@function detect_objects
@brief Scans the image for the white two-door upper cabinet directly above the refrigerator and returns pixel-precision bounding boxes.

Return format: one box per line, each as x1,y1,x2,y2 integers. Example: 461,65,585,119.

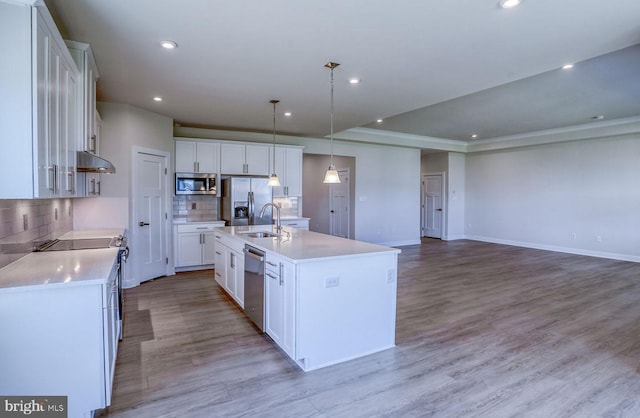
220,143,271,176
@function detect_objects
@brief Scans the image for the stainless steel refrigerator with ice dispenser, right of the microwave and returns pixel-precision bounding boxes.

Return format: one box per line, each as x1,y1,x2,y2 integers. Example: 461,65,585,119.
222,177,273,226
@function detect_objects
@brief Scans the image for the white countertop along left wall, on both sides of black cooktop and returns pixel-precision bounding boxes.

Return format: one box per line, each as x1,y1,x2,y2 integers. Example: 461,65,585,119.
0,228,125,293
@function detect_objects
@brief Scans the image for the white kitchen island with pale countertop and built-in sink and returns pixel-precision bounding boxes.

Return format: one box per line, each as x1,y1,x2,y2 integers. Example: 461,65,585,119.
216,225,400,371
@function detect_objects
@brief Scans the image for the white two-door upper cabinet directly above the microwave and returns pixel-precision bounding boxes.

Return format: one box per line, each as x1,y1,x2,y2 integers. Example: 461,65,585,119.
176,140,220,173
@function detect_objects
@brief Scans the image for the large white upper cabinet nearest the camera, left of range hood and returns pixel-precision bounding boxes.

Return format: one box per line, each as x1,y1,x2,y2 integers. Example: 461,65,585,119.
0,1,80,199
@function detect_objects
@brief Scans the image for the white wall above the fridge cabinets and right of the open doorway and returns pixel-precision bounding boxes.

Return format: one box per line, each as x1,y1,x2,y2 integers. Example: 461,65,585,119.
175,128,420,246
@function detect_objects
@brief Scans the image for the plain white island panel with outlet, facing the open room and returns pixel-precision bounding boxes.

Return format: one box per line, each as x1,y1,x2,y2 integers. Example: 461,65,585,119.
294,253,397,371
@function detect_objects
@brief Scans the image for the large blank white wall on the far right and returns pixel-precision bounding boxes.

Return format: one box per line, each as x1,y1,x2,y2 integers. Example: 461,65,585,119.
465,135,640,261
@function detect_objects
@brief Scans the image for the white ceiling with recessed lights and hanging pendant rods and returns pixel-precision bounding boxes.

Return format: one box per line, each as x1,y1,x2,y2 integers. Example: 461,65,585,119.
47,0,640,146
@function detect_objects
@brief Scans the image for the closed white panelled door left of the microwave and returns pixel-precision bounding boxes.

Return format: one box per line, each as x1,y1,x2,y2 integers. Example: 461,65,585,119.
132,152,167,282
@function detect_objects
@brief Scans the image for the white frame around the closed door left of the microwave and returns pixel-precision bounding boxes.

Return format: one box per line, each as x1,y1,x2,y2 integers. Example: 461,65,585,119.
126,145,173,287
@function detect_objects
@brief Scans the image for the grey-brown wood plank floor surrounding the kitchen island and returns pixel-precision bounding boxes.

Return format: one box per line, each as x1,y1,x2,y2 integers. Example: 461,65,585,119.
103,240,640,418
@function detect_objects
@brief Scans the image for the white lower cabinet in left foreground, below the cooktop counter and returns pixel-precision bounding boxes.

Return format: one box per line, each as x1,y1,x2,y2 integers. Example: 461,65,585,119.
0,256,121,417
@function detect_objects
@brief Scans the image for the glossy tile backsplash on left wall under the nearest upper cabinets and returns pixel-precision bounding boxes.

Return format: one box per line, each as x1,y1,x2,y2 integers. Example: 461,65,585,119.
0,199,73,268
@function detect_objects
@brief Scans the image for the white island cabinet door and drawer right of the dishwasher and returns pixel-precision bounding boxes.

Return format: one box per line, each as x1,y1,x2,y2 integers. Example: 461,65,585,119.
264,252,295,358
